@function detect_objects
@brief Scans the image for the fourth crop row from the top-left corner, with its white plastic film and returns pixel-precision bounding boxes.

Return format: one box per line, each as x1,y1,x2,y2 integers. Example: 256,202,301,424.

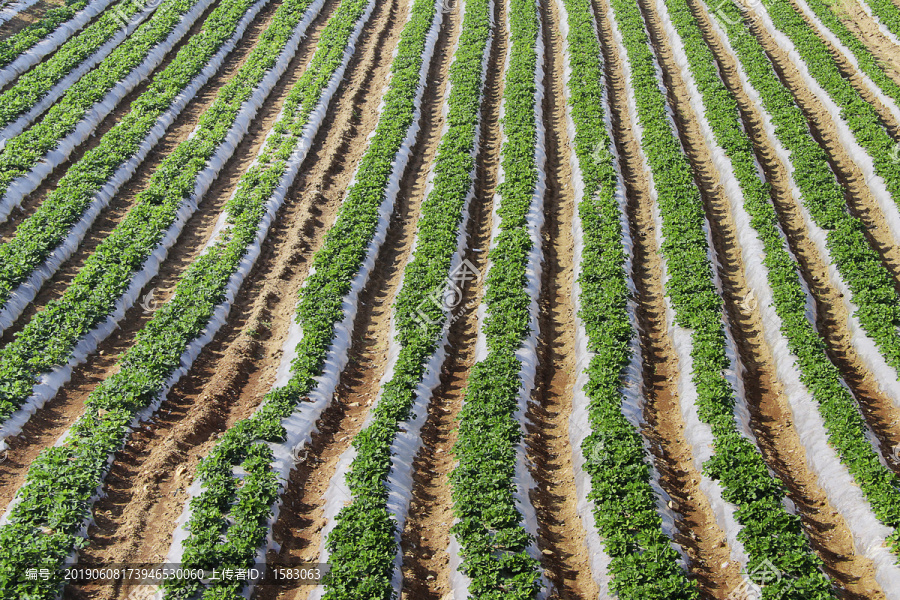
0,2,282,330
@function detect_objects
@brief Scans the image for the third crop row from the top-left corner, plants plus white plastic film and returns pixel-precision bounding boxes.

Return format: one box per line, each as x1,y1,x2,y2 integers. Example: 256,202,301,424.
0,0,214,219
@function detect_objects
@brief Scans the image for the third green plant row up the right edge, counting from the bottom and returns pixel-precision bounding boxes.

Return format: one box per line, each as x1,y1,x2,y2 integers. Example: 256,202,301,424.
765,0,900,214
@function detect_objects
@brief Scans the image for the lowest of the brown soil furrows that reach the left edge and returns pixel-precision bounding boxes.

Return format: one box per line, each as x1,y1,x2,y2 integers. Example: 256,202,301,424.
0,0,358,524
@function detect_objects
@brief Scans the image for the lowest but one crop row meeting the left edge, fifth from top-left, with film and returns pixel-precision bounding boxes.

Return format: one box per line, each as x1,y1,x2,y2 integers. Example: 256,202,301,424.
0,0,308,446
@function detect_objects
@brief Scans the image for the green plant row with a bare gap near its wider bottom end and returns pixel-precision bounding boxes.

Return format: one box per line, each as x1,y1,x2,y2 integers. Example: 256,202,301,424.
167,0,440,598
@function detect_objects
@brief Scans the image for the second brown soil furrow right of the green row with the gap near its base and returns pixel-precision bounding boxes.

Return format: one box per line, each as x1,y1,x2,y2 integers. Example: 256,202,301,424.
392,1,509,600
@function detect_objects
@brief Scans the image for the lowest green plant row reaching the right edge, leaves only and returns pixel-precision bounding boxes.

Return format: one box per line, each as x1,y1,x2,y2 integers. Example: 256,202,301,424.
665,0,900,553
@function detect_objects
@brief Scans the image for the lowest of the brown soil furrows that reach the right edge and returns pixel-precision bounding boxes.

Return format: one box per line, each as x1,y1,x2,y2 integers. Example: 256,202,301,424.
688,0,900,478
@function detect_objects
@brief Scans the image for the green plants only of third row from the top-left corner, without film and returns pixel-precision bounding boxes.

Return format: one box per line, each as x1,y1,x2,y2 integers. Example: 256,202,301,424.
0,0,211,198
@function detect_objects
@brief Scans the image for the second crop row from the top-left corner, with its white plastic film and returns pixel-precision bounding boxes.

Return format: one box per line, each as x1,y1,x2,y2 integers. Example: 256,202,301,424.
0,0,158,138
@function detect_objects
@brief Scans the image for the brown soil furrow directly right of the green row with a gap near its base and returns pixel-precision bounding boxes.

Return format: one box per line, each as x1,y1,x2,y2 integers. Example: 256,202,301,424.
256,2,461,600
